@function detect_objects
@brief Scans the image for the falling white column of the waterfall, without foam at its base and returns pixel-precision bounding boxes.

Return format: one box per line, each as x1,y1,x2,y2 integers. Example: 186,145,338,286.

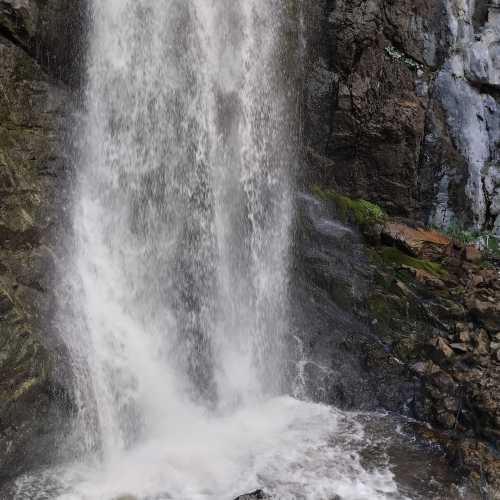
72,0,294,453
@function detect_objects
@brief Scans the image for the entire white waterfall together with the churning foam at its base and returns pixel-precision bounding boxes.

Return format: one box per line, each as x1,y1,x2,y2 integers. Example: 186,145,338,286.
9,0,474,500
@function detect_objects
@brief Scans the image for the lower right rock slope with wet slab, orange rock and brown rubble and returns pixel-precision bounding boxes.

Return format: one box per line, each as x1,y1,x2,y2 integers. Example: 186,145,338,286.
293,191,500,488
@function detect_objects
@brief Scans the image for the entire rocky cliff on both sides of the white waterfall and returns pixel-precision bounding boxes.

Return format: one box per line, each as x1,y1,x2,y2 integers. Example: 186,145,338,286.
0,0,500,499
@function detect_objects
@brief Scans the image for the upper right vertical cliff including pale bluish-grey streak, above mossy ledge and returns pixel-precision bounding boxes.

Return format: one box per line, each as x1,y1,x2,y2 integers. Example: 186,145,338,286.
306,0,500,230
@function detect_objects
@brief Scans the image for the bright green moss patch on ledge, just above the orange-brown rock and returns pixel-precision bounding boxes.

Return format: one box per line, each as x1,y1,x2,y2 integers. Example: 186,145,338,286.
312,186,387,226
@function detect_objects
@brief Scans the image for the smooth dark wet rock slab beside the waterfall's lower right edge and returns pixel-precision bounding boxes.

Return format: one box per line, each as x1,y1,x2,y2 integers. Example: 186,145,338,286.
291,195,421,412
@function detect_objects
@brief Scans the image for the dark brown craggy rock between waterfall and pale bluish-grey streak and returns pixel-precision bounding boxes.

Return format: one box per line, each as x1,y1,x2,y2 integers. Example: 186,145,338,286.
306,0,446,215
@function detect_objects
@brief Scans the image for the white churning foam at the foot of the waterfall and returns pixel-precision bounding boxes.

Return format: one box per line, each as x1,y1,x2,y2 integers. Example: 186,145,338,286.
17,397,403,500
